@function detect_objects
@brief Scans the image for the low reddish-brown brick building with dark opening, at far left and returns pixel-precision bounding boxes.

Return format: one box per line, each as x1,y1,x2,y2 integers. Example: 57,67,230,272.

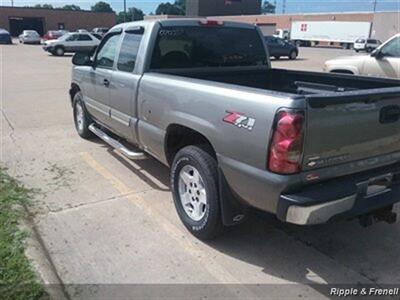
0,6,116,36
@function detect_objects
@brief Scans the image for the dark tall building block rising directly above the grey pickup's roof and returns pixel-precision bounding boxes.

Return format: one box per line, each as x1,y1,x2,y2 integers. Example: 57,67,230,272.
186,0,261,17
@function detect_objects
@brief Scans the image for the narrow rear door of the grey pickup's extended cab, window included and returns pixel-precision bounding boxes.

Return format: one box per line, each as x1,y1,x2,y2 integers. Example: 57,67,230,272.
110,27,144,143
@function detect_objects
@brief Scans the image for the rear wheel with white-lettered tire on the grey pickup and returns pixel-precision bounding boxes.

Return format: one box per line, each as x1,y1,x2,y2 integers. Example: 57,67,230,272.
171,146,224,240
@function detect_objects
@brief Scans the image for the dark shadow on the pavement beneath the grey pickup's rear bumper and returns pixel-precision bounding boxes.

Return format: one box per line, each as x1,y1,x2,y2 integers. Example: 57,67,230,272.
208,207,400,298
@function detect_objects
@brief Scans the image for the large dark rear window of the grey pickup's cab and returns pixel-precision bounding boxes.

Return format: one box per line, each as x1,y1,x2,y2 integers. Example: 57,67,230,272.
151,26,267,69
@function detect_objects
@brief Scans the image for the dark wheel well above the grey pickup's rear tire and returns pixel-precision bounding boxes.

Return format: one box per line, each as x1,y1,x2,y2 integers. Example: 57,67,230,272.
165,124,217,165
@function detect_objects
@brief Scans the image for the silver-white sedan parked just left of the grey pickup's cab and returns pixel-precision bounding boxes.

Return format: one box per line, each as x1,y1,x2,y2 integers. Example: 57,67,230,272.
43,32,100,56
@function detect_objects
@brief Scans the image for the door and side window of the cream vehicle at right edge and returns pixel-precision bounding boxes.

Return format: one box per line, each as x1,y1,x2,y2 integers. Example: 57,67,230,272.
362,36,400,78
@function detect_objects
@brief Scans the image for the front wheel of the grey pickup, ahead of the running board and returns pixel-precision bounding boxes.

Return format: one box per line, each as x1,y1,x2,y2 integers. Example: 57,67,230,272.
73,92,94,139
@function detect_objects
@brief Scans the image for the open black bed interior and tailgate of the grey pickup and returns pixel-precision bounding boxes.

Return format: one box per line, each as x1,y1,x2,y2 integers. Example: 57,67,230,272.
152,69,400,177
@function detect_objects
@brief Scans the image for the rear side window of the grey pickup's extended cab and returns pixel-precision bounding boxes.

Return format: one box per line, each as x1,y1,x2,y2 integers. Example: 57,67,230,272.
117,33,143,72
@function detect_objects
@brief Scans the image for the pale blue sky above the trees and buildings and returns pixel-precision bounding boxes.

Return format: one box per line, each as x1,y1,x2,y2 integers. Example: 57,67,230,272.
0,0,400,14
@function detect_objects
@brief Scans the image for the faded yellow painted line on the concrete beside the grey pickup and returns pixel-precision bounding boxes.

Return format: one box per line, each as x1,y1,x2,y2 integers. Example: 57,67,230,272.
80,152,249,286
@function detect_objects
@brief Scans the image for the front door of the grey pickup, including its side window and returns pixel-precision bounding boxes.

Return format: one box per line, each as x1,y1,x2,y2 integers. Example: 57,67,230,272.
85,33,121,125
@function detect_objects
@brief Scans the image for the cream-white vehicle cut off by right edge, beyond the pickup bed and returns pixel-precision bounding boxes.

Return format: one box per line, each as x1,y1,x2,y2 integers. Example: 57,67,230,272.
324,34,400,78
